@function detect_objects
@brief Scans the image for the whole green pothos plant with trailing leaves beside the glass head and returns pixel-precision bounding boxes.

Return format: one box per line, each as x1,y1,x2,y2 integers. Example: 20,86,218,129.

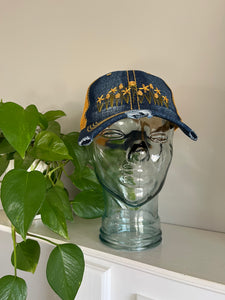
0,101,104,300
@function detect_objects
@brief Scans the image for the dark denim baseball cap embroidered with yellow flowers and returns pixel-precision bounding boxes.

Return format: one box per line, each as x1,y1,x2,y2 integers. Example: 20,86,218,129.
78,70,198,146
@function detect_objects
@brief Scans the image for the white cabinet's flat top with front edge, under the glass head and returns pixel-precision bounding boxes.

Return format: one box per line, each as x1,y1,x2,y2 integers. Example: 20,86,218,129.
0,211,225,297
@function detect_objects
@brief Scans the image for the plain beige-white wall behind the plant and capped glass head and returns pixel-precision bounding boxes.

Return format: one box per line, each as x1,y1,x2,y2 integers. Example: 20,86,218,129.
0,0,225,231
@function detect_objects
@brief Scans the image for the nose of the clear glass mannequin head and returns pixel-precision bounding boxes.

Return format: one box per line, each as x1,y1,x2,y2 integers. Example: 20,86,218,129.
127,141,150,163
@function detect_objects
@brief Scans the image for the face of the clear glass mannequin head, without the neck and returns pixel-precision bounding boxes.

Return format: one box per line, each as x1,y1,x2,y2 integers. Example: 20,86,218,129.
93,117,174,207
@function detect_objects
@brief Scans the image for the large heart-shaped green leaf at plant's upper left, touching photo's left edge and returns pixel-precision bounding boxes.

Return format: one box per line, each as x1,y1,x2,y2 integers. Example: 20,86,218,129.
0,102,39,157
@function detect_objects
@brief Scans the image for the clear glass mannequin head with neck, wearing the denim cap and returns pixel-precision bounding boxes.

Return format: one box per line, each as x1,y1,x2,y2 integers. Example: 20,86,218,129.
92,117,174,250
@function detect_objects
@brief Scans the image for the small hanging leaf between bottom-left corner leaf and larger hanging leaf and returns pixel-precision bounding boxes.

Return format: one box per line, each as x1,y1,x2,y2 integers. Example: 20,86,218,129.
11,239,40,273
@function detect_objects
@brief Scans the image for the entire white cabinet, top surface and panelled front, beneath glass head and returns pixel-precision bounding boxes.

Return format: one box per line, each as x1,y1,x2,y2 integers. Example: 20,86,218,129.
0,212,225,300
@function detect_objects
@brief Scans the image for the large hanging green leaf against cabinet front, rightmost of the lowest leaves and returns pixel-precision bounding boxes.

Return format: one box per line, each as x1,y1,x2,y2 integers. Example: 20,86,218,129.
46,244,84,300
